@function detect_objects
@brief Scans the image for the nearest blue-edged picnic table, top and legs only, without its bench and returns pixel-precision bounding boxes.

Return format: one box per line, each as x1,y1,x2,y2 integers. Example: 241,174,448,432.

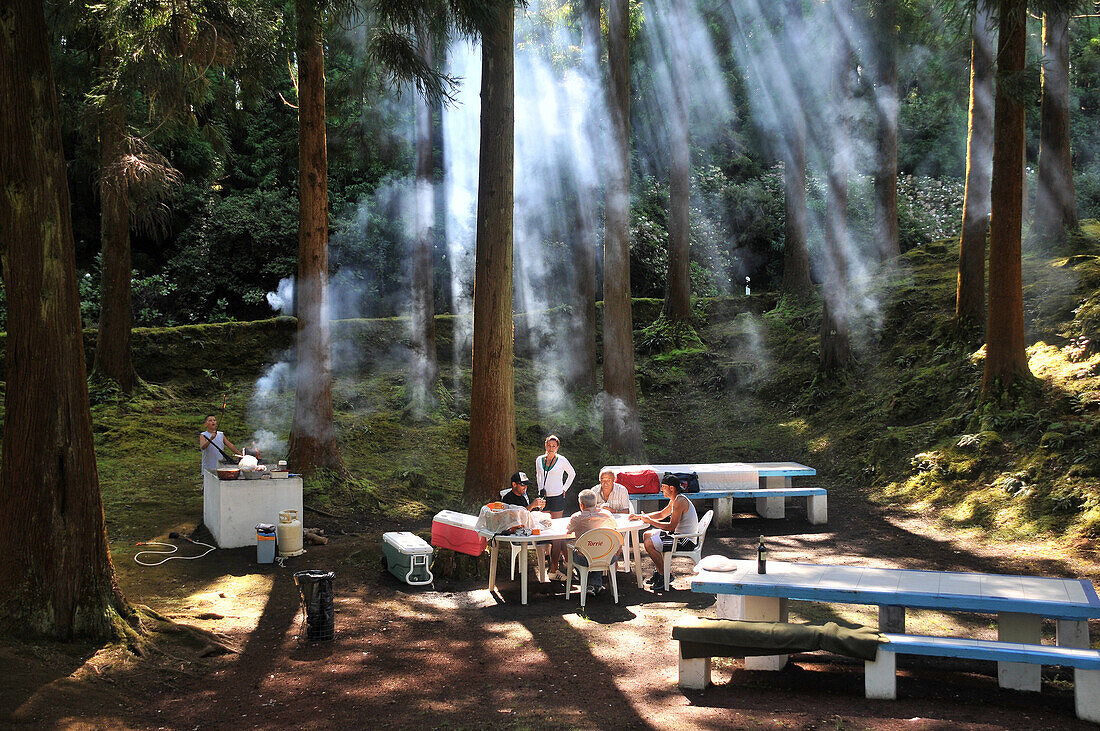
691,561,1100,690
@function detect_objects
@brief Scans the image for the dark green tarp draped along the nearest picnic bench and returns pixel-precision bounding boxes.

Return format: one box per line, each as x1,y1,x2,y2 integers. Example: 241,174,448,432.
672,618,883,661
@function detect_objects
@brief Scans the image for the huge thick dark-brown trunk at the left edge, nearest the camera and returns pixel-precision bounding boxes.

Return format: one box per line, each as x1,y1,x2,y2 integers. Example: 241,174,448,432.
0,0,130,640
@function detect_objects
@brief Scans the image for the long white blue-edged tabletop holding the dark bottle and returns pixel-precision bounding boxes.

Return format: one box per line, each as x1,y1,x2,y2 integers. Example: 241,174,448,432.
691,561,1100,620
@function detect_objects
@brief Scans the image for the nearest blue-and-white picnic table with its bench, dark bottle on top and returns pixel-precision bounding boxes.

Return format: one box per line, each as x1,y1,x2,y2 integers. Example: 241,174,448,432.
691,560,1100,721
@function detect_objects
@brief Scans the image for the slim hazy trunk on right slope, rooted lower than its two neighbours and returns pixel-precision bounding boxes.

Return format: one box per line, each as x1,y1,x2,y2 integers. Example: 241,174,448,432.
820,0,854,373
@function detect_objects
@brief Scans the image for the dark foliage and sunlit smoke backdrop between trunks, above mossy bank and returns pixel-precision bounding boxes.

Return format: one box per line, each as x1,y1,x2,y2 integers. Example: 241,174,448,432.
0,0,1100,328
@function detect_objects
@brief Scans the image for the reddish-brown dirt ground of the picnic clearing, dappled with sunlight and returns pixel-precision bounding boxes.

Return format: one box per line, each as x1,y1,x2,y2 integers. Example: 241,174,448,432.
0,485,1096,729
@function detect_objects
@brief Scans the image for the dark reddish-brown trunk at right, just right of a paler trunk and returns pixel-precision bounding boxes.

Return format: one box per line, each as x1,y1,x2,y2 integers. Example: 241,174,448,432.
981,0,1032,399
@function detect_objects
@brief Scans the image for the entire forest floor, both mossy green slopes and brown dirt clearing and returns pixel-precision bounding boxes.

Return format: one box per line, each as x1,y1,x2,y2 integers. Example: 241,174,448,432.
0,223,1100,729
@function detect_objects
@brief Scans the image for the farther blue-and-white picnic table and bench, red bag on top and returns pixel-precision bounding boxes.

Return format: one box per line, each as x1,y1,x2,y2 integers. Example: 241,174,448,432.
601,462,828,528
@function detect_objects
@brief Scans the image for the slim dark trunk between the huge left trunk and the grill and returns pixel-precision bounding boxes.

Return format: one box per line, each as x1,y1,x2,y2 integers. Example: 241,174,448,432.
92,82,136,394
